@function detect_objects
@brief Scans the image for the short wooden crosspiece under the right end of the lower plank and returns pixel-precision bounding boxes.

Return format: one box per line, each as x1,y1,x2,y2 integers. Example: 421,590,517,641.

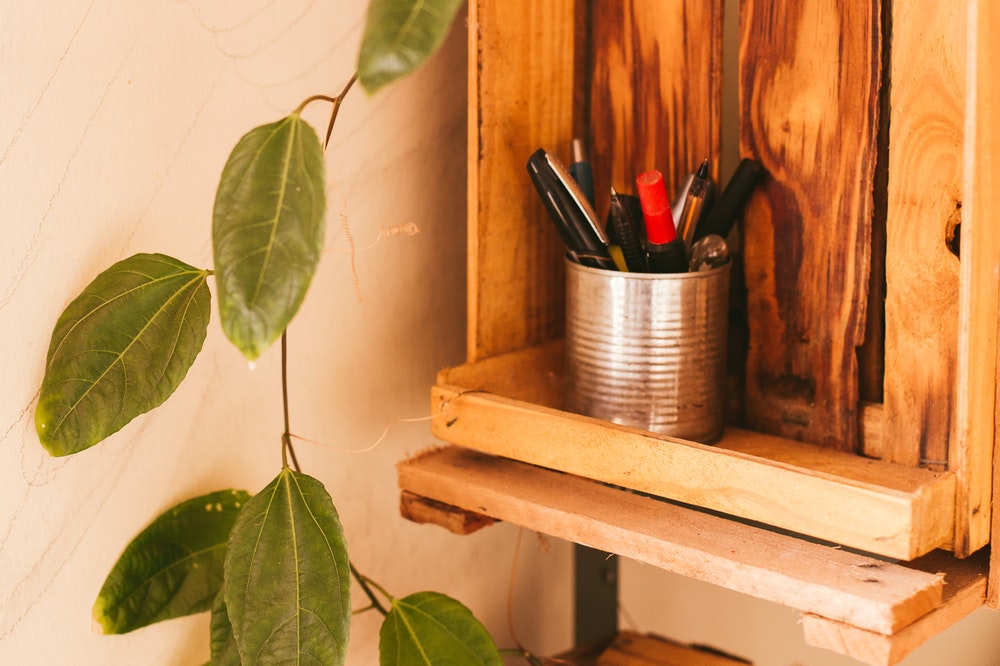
802,553,988,666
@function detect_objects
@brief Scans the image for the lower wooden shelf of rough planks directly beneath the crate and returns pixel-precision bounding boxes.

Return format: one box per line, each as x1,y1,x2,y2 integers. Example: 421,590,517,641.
398,446,987,665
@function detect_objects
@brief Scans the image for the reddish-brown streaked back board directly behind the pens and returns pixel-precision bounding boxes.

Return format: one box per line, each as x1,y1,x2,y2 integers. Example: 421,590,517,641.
590,0,723,211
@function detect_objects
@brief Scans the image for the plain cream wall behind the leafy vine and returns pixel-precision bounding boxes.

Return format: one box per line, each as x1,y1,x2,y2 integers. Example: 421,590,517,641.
0,0,570,666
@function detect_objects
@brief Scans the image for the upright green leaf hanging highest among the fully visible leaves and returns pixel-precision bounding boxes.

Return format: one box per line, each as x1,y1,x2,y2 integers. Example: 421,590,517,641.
212,114,326,360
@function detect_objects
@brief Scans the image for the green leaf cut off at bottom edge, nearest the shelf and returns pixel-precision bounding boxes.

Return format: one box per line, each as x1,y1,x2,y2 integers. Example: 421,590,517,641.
379,592,503,666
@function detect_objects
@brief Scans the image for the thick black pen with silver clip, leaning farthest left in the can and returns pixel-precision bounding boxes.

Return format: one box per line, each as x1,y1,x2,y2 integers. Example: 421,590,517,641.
527,148,616,270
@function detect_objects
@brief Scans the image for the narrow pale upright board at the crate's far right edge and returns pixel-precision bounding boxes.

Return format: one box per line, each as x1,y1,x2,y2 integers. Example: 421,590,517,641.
949,0,1000,560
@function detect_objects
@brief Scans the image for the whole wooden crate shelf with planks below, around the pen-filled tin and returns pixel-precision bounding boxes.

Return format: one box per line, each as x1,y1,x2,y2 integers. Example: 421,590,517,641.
390,0,1000,664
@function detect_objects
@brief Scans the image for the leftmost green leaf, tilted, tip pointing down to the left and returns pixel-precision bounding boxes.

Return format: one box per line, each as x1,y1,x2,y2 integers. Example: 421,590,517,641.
35,254,211,456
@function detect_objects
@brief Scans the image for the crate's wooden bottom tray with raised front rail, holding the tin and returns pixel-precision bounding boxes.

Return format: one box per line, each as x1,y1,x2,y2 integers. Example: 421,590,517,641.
431,344,955,559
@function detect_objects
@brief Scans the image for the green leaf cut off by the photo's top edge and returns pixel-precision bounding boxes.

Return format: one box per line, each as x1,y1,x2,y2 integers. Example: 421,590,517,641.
358,0,464,93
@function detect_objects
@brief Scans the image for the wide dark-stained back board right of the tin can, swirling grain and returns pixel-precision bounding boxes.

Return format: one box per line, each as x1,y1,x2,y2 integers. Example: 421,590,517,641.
740,0,881,450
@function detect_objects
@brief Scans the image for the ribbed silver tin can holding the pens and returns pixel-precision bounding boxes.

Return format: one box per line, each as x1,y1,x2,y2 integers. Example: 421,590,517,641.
566,259,730,444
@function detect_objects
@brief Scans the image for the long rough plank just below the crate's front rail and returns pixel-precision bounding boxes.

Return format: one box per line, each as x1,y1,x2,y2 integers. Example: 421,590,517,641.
398,447,942,633
